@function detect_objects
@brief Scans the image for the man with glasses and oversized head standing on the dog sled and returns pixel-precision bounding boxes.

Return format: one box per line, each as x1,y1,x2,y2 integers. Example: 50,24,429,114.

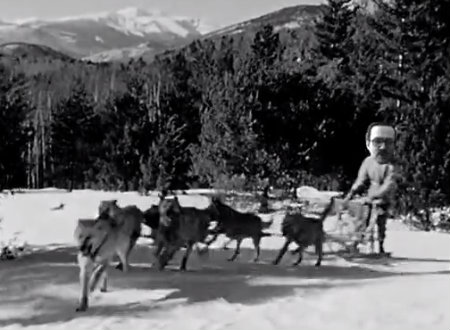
344,122,398,254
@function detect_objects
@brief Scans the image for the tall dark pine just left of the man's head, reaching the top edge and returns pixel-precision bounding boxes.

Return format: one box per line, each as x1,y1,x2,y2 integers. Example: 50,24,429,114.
304,0,364,175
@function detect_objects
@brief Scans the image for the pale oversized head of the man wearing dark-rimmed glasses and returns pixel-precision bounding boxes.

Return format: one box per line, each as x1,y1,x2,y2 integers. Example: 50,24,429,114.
366,125,395,164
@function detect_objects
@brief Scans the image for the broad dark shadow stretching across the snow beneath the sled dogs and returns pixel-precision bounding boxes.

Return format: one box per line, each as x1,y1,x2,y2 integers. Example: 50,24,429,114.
0,246,449,327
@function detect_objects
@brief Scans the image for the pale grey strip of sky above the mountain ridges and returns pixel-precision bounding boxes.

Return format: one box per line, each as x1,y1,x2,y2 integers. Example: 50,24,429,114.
0,0,323,27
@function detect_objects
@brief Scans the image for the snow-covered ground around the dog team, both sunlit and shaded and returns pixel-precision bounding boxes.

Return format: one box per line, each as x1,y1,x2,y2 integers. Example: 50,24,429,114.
0,190,450,330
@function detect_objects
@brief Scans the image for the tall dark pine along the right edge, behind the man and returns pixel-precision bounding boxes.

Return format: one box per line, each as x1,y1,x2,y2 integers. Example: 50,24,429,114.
374,0,450,215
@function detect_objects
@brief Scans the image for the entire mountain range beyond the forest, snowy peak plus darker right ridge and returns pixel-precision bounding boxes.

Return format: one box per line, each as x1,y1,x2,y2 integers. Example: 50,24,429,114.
0,5,322,62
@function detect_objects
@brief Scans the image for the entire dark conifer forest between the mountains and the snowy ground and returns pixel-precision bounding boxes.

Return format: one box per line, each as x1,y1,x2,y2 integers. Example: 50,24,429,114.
0,0,450,217
